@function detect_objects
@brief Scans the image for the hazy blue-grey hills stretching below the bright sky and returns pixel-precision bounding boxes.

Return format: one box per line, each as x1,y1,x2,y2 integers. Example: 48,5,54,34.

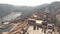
0,2,60,17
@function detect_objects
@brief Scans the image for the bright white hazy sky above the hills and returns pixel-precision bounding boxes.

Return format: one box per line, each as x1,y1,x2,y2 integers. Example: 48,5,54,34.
0,0,60,6
